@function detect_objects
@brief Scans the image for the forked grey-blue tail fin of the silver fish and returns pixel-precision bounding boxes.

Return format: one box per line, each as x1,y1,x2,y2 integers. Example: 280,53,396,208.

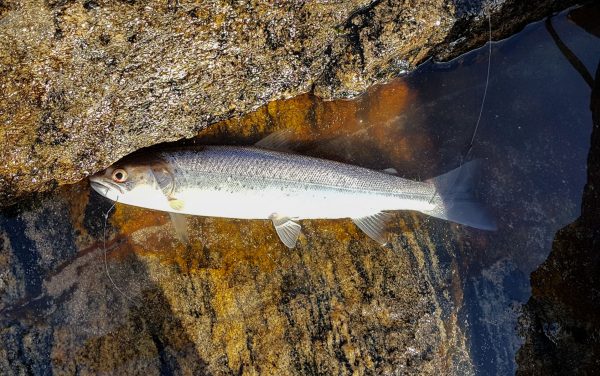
423,160,497,230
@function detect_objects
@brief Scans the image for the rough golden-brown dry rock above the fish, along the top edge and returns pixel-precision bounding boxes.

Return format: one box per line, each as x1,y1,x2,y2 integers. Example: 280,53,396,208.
0,0,575,205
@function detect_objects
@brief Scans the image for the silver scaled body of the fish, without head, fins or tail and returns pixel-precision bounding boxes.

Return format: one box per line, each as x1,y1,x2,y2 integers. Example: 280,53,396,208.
159,146,435,219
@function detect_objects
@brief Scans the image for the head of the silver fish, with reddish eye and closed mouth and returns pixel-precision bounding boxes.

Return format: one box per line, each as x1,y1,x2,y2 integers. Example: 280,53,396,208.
89,156,174,209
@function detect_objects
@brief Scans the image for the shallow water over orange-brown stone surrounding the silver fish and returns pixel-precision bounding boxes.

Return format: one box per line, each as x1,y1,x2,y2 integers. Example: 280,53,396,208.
0,4,600,374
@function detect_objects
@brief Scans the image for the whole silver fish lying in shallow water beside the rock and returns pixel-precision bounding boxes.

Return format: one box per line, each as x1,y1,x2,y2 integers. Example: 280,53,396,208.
89,143,496,248
